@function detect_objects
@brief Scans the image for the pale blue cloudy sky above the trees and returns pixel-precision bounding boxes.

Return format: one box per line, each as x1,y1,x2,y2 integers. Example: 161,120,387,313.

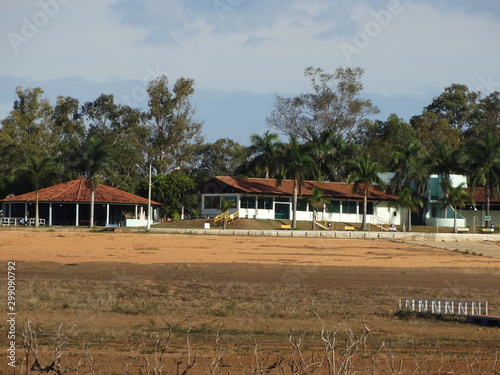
0,0,500,144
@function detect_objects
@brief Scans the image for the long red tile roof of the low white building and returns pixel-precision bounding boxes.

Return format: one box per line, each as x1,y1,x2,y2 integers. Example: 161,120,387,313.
214,176,399,200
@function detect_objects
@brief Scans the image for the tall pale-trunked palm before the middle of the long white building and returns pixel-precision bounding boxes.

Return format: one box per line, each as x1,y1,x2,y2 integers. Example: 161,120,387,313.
276,135,317,229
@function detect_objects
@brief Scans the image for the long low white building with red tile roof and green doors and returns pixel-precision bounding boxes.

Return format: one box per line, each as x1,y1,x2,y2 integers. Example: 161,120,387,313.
201,176,401,225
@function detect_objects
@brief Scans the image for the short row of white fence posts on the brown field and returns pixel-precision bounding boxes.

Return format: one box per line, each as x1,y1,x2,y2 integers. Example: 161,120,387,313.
399,298,488,316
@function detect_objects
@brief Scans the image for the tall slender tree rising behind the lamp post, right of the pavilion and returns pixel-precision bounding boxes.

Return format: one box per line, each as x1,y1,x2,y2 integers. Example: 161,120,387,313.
146,76,202,173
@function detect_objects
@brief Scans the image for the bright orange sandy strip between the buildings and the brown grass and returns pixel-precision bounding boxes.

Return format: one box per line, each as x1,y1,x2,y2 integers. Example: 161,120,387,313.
0,231,500,269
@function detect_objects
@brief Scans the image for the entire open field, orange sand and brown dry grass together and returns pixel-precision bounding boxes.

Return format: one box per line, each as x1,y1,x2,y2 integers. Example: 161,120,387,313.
0,231,500,375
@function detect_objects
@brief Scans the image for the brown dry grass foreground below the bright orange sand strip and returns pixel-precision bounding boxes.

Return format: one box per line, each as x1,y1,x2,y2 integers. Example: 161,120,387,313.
0,234,500,375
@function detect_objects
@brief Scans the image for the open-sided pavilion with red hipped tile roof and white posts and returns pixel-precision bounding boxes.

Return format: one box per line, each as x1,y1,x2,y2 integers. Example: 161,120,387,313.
0,177,162,226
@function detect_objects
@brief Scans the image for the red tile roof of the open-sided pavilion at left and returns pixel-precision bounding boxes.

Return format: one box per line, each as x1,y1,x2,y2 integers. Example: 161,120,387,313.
2,177,163,206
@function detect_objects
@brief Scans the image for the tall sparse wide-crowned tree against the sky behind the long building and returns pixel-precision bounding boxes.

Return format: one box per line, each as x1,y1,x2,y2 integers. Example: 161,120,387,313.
267,67,379,140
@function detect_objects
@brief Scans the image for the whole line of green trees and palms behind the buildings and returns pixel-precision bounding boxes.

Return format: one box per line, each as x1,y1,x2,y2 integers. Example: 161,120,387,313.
0,67,500,225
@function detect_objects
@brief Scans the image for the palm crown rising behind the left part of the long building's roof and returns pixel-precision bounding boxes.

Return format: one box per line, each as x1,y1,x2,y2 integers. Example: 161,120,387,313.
250,130,280,178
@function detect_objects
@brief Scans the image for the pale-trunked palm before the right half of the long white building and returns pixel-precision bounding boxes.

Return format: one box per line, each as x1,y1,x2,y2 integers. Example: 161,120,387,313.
346,154,385,230
